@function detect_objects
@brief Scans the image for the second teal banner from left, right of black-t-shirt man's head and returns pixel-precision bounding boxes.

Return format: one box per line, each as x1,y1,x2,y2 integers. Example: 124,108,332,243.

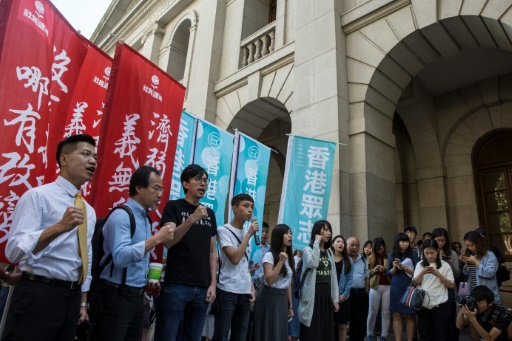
193,120,233,226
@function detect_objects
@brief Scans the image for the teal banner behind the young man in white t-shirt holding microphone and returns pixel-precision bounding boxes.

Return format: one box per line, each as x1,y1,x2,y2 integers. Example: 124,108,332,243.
229,131,270,262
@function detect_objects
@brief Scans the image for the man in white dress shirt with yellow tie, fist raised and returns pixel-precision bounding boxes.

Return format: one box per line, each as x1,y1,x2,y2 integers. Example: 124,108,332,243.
2,134,98,340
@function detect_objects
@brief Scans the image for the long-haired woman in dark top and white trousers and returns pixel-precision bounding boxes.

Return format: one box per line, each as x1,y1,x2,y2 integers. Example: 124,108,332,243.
366,237,391,341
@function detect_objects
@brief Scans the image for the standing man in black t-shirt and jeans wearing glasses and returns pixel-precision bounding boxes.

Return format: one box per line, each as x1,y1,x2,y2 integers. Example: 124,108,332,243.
155,164,217,341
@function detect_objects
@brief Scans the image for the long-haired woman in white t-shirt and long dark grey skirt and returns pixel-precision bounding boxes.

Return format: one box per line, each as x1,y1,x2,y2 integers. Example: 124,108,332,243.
254,224,295,341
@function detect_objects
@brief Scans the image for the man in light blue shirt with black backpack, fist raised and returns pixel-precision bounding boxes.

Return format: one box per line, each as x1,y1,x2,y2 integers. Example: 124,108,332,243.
91,166,178,341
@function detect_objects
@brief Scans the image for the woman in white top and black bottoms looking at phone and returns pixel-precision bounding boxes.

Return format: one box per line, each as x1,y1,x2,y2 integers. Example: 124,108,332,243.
412,239,454,341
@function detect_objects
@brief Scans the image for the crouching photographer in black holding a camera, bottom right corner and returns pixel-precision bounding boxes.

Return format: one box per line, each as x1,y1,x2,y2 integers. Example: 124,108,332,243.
457,285,510,341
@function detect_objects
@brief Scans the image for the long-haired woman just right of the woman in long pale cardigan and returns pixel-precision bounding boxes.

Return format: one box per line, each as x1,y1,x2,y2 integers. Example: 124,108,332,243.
332,235,354,341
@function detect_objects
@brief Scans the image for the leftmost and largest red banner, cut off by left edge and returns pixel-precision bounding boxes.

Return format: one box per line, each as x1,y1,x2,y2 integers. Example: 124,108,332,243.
0,0,87,262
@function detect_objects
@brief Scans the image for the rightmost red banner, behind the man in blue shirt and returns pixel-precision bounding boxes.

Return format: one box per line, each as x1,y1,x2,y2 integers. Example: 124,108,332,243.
91,44,185,257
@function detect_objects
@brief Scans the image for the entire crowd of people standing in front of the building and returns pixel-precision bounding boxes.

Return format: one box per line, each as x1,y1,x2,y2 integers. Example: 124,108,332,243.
0,135,512,341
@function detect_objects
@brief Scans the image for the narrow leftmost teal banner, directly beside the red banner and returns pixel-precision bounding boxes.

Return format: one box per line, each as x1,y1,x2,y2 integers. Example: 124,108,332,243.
169,111,197,200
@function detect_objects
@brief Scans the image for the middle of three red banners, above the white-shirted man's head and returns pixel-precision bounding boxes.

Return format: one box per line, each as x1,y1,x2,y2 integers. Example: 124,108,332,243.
45,42,112,200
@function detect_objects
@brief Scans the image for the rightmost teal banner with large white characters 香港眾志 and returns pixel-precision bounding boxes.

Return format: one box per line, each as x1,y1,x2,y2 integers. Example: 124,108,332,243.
278,136,336,250
